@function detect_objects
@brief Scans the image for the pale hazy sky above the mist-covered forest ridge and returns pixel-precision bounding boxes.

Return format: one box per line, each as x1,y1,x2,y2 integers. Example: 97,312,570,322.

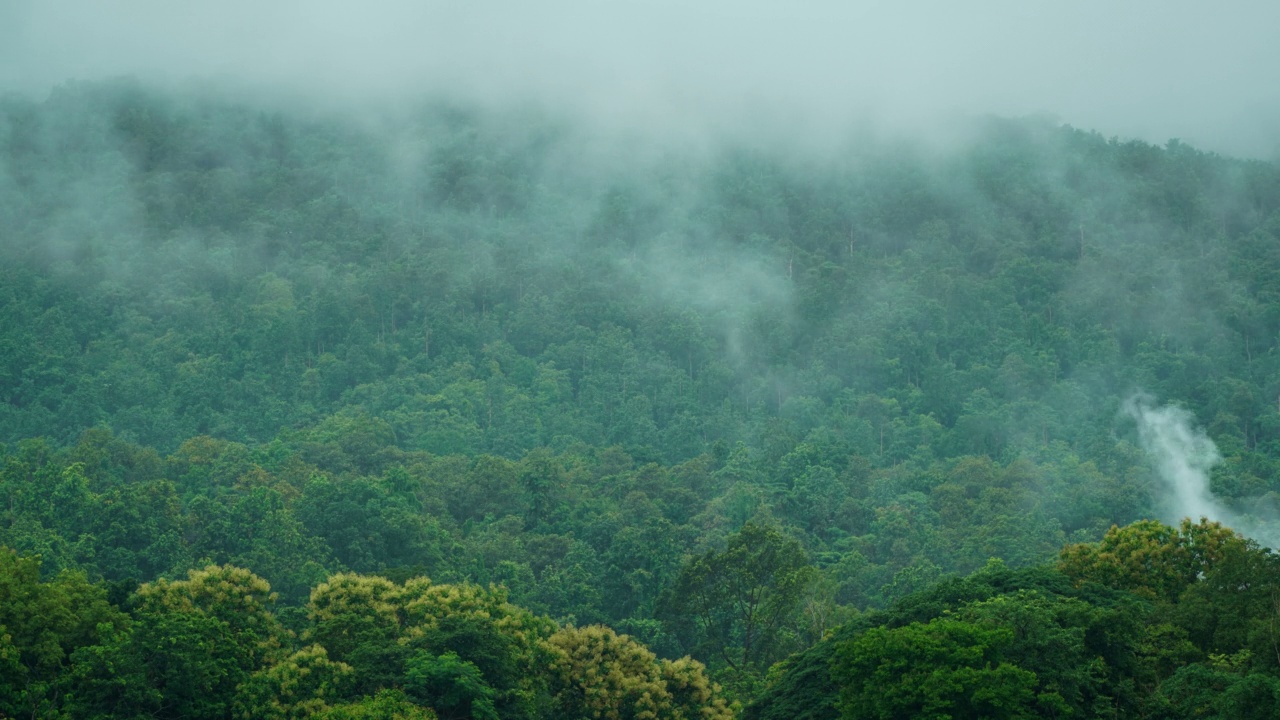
0,0,1280,158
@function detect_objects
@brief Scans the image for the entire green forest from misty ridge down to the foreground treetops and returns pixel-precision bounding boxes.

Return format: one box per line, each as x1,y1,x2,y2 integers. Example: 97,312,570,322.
0,79,1280,720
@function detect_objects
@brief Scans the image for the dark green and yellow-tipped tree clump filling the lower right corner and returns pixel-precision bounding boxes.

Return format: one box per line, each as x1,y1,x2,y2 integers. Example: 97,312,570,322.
745,521,1280,719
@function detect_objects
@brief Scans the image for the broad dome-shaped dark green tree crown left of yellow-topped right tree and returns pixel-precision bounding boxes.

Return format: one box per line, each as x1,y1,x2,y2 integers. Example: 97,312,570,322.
744,562,1148,720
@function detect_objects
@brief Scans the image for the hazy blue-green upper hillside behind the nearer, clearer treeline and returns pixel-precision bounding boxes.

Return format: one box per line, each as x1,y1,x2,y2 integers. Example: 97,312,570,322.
10,78,1280,461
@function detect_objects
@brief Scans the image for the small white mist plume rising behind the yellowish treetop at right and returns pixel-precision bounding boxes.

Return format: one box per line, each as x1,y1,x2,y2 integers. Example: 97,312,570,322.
1124,395,1235,525
